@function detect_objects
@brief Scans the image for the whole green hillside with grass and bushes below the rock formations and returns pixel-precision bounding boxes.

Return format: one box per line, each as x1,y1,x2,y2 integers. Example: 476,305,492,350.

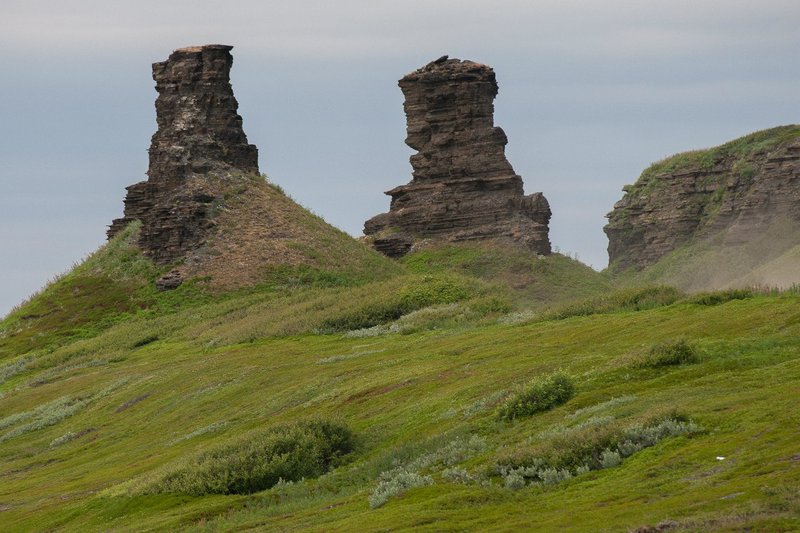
0,226,800,531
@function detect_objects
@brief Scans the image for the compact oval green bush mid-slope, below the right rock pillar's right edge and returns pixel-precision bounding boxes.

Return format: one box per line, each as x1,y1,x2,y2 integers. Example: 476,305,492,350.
497,373,575,420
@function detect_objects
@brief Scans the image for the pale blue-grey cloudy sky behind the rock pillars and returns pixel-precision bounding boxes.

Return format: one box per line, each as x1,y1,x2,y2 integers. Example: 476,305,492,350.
0,0,800,316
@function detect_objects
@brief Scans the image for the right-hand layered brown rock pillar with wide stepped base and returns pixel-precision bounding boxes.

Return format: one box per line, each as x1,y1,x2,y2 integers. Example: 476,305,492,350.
364,56,550,257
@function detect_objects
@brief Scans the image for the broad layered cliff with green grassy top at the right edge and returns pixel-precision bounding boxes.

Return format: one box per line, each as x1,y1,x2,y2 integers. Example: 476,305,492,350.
604,126,800,270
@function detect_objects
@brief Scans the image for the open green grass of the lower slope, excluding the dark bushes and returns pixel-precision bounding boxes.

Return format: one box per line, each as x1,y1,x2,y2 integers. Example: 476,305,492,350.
0,272,800,531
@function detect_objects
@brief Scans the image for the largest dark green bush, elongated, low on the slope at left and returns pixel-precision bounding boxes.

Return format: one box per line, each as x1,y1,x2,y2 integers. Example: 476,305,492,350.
139,420,354,496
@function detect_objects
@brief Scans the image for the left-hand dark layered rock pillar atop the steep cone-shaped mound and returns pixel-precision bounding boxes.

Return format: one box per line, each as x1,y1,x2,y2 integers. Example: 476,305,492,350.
108,44,258,264
